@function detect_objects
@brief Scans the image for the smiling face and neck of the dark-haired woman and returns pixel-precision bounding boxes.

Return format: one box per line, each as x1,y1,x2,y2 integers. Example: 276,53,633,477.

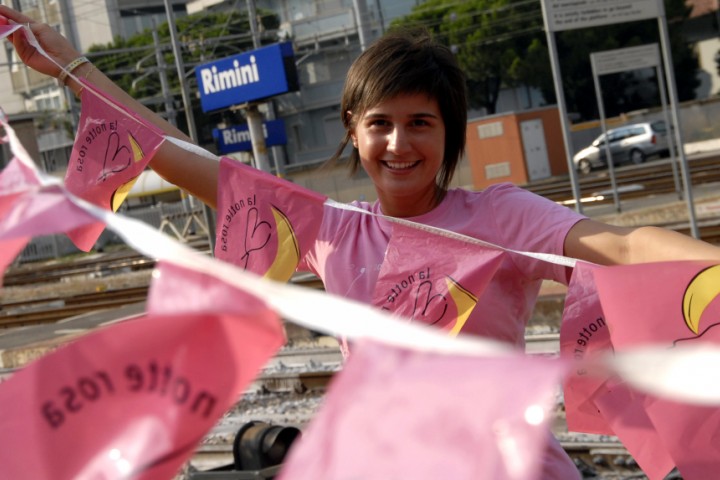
351,94,445,217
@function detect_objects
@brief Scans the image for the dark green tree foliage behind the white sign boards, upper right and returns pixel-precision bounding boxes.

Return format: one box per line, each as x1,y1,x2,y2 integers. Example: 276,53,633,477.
394,0,699,119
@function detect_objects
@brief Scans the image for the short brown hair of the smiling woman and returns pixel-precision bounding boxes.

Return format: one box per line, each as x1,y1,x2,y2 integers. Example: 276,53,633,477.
333,27,467,191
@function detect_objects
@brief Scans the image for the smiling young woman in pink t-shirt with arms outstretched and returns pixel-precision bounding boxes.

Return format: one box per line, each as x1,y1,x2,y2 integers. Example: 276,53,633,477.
0,6,720,480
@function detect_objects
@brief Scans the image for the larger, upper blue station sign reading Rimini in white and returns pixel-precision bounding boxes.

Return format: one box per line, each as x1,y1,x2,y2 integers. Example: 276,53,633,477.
195,42,300,112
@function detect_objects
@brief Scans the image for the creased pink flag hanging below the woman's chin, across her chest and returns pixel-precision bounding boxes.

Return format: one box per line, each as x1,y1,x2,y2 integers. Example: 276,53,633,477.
373,224,505,335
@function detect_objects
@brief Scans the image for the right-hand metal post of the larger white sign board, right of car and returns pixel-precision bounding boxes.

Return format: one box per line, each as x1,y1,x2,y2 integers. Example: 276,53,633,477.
658,12,700,238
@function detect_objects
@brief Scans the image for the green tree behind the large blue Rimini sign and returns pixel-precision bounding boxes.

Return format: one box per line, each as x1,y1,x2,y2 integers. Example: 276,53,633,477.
88,10,280,144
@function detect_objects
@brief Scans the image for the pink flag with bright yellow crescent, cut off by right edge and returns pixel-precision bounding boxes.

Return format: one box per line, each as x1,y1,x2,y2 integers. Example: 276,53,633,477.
595,262,720,480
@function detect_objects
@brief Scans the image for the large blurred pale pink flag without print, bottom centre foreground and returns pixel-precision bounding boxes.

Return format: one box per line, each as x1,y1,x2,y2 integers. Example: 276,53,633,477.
280,342,564,480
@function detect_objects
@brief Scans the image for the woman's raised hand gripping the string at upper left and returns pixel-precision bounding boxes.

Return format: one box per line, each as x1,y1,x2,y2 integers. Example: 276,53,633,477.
0,5,80,78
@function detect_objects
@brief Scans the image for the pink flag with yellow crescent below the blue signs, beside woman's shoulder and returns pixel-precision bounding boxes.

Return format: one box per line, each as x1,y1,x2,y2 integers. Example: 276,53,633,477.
215,158,327,282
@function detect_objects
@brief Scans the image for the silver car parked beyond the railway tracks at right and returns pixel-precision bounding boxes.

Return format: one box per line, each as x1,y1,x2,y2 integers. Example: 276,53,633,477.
573,120,669,174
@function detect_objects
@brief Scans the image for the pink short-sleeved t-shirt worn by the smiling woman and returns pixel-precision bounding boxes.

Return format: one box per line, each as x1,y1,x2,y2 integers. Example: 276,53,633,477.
298,183,585,480
